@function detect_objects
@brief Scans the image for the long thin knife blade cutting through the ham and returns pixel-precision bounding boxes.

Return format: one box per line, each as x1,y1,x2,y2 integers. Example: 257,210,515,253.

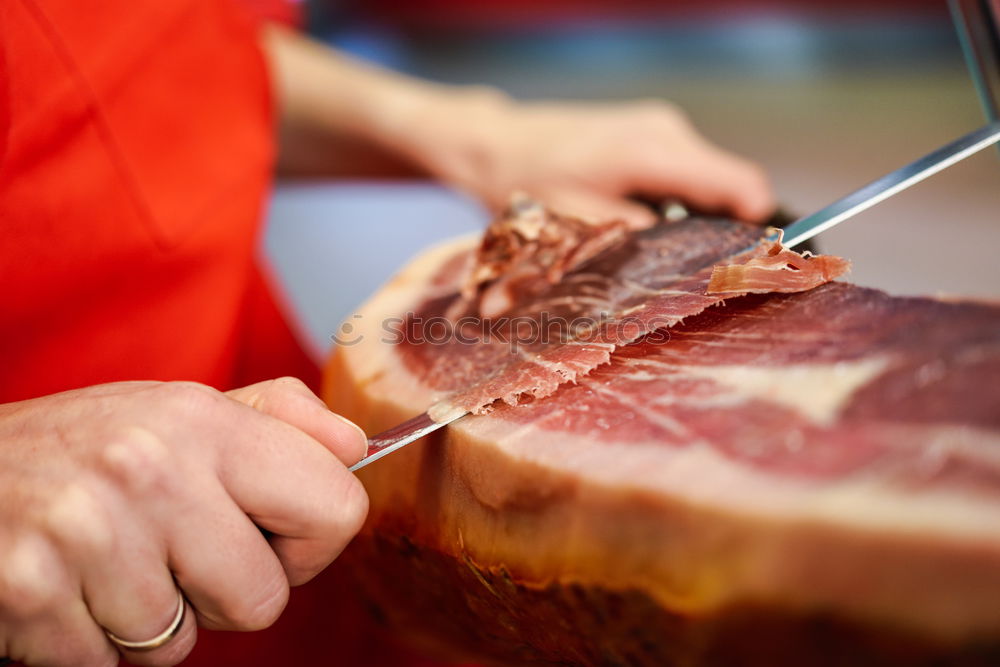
350,121,1000,470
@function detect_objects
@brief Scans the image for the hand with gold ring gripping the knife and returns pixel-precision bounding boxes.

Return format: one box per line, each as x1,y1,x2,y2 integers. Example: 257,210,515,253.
0,378,368,666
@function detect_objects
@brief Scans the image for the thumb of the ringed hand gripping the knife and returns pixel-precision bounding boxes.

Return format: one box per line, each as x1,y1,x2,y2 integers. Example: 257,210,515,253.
227,377,368,465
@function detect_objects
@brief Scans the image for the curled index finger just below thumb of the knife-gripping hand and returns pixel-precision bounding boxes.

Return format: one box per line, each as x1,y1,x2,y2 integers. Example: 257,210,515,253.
188,394,368,588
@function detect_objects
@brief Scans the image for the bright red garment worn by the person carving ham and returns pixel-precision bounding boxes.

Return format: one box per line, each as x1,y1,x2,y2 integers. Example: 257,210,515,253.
0,0,438,665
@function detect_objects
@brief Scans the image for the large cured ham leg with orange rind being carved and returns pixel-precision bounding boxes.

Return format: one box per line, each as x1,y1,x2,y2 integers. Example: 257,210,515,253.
325,220,1000,665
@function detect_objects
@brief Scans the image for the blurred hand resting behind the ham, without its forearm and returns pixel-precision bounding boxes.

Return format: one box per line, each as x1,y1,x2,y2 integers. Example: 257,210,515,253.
400,90,775,228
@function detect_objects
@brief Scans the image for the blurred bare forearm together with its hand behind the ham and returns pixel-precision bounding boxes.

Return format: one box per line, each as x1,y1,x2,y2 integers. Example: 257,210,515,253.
263,28,774,227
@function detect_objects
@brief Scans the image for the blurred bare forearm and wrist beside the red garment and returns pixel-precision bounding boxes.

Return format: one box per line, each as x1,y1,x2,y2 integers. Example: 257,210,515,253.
264,27,513,191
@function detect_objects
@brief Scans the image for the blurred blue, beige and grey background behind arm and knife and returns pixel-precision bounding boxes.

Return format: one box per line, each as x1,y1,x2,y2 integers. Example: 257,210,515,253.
264,0,1000,356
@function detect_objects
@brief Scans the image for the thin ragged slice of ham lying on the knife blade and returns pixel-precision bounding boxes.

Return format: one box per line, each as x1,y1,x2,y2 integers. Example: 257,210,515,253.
428,215,849,422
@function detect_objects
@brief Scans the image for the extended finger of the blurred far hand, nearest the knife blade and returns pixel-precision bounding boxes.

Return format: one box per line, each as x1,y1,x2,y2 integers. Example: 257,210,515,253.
628,140,775,222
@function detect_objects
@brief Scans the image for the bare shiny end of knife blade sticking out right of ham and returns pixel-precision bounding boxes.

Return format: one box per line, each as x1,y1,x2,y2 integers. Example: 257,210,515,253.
782,121,1000,247
